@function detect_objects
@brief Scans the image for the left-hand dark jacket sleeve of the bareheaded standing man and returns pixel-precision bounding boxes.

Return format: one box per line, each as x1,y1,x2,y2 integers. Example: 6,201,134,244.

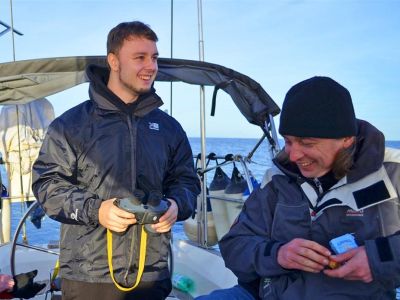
32,119,101,225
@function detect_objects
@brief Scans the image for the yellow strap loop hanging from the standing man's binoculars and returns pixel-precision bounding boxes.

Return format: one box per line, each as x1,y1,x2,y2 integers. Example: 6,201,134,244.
107,225,147,292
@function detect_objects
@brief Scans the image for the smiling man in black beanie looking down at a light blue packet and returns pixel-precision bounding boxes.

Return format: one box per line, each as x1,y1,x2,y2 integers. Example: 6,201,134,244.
211,77,400,300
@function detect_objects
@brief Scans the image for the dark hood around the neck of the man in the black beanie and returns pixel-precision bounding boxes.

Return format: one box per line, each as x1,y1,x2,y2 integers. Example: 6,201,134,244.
273,119,385,184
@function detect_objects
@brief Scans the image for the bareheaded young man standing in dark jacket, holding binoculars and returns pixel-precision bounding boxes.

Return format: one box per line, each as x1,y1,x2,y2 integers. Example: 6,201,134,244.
33,22,200,300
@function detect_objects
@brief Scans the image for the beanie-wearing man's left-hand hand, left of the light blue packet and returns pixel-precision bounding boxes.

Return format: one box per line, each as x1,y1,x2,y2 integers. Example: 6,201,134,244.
277,238,331,273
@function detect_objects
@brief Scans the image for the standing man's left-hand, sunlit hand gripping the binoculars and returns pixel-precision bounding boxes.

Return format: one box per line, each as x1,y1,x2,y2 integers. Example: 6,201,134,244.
99,198,136,232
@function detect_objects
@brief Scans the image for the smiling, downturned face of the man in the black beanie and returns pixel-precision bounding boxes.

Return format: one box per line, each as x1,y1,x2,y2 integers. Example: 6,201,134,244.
284,136,354,178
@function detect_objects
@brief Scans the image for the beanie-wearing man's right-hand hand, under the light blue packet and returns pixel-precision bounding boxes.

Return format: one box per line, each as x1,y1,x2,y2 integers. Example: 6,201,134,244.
324,246,373,283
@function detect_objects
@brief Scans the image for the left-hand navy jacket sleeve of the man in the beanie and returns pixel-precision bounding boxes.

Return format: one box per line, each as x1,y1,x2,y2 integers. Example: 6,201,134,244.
219,185,290,282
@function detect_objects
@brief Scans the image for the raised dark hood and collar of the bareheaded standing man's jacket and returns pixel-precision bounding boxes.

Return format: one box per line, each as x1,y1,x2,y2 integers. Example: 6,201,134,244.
86,65,163,117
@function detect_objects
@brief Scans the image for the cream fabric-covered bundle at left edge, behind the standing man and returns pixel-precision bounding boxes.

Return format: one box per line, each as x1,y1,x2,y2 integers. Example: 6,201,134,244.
0,98,54,201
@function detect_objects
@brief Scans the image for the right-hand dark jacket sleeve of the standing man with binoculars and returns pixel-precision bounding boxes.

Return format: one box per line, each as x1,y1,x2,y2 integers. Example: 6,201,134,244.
163,128,200,221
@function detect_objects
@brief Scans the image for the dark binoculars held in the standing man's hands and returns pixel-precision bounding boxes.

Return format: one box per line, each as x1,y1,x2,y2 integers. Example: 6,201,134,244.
114,190,170,224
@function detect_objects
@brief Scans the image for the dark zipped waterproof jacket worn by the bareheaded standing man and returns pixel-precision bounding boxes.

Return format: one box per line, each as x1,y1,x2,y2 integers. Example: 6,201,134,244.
33,66,200,286
